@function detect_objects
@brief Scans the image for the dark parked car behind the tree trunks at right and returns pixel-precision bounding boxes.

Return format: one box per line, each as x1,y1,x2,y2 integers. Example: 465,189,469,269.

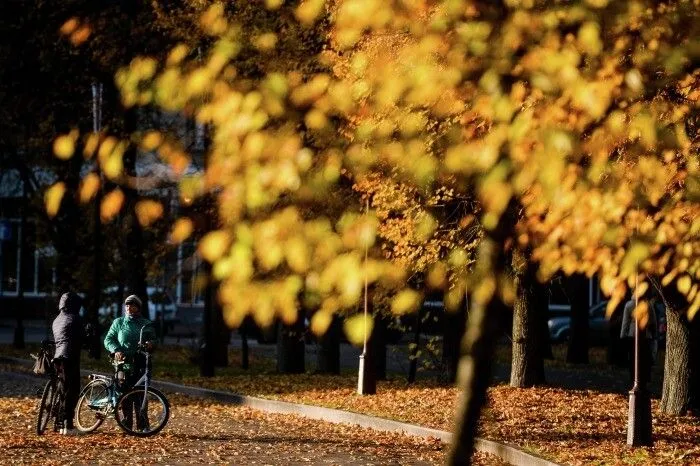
547,301,666,343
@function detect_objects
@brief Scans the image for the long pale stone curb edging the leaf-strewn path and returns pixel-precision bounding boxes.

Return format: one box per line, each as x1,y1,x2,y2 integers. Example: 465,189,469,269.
0,356,559,466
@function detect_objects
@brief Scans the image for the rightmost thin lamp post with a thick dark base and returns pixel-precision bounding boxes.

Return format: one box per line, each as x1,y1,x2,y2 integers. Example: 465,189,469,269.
627,277,654,447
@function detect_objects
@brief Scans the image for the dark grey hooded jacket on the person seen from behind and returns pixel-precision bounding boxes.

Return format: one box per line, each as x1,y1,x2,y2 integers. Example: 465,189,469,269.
51,293,85,360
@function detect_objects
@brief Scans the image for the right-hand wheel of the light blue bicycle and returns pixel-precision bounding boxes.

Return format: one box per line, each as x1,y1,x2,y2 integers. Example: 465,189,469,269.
114,388,170,437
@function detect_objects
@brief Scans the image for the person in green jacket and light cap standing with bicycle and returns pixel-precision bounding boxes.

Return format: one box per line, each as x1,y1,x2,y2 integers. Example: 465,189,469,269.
104,295,156,429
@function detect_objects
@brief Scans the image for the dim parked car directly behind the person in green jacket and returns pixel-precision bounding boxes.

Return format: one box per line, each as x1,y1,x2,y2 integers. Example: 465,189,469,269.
98,286,178,328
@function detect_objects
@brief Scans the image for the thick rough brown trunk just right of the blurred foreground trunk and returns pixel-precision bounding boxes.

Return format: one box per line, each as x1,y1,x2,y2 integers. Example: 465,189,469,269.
510,252,545,387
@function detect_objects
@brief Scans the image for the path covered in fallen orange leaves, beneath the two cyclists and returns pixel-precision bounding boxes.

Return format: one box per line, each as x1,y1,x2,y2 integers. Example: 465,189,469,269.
0,372,500,465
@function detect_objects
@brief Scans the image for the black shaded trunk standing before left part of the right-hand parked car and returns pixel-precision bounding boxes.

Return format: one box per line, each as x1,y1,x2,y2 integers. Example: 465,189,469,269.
565,274,588,364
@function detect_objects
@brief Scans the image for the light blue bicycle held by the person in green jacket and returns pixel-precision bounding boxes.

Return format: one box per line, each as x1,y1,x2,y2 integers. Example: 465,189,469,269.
75,324,170,437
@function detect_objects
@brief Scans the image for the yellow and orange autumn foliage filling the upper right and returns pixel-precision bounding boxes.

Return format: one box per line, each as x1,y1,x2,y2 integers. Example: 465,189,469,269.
49,0,700,338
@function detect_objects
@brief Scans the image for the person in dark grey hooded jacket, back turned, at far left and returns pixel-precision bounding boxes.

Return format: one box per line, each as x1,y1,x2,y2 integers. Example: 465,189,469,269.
51,292,84,435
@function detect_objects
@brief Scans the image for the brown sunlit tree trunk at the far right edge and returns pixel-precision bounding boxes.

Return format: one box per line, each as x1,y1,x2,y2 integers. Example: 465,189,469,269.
661,296,691,415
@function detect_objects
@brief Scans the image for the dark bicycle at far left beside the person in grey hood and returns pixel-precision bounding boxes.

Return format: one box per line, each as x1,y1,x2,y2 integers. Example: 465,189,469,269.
32,340,66,435
